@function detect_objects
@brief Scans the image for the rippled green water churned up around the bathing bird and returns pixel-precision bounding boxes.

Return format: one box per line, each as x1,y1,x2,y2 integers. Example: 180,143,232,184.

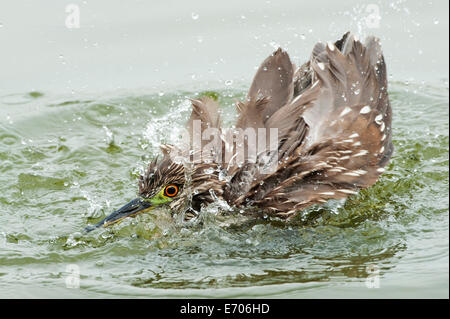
0,81,449,298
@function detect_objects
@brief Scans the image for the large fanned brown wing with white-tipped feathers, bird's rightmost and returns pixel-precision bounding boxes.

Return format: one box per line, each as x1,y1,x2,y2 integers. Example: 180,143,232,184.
230,35,393,217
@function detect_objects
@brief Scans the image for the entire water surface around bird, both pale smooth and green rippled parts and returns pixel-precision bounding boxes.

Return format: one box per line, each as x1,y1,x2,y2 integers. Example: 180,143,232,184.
0,1,449,298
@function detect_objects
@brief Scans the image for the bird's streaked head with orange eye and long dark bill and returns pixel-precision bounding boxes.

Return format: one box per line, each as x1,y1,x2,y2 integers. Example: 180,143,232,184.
85,156,187,232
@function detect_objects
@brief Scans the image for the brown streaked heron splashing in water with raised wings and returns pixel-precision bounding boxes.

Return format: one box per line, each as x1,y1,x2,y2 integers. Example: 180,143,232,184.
85,32,394,232
